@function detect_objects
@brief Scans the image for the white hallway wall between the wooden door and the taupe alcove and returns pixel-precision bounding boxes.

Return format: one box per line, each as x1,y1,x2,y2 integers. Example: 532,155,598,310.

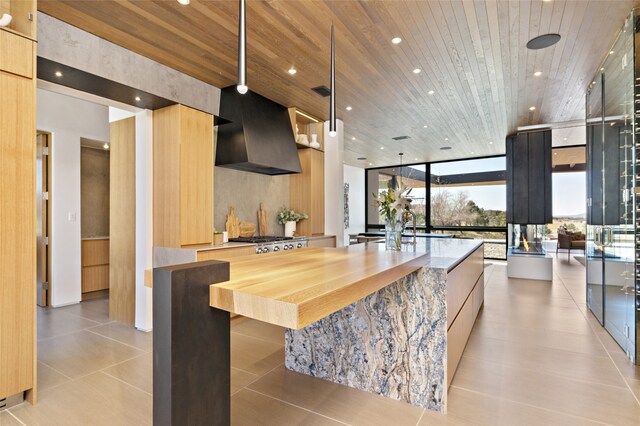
36,89,109,307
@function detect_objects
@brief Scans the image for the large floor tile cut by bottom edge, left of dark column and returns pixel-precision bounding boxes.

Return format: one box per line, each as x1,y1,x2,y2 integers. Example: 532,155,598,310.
11,372,152,426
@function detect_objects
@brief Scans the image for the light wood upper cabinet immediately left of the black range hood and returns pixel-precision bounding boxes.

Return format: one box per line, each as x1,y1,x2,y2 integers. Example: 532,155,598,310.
153,105,215,247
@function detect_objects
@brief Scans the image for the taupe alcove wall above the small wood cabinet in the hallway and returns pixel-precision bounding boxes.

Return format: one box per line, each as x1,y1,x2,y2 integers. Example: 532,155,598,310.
80,146,109,238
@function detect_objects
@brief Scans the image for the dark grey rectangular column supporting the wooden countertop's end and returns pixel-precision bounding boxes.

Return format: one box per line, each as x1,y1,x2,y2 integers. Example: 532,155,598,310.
153,261,231,426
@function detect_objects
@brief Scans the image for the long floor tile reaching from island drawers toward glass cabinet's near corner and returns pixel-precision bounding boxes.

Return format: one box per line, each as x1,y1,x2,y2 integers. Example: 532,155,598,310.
464,335,625,387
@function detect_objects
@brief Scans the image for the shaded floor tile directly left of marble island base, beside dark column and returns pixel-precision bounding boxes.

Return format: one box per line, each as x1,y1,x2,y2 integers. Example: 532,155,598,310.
231,333,284,376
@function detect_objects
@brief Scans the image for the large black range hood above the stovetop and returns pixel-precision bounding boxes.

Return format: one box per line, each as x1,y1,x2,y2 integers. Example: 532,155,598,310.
216,86,302,175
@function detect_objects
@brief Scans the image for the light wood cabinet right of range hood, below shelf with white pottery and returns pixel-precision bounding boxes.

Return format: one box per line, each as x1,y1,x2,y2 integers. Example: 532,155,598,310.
289,149,324,236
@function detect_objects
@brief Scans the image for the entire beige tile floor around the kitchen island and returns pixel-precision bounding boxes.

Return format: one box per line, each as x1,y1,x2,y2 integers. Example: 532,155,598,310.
0,256,640,426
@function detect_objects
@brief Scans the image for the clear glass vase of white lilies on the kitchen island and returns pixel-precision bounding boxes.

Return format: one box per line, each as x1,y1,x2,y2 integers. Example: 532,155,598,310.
373,184,413,250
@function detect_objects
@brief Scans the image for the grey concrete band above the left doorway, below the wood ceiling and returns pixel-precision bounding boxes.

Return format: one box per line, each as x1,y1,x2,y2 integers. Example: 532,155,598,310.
38,13,220,114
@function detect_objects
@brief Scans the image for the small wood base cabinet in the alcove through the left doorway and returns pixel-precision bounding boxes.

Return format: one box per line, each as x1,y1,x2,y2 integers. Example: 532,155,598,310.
82,239,109,293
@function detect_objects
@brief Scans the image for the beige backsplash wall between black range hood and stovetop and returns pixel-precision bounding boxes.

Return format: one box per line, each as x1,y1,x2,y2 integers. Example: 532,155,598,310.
213,167,290,235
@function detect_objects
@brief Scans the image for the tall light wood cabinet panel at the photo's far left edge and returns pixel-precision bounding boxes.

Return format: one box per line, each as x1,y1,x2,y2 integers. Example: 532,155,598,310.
0,29,36,402
